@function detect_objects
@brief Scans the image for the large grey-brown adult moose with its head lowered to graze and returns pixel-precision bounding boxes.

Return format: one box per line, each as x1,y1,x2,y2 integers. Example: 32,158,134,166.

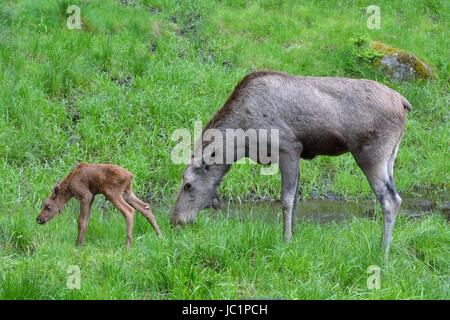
171,71,411,256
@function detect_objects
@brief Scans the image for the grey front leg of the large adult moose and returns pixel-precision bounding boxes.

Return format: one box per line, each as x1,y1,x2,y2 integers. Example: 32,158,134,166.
279,150,300,242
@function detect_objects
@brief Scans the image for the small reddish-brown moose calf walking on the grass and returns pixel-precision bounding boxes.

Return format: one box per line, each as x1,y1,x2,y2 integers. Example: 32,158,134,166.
36,163,161,247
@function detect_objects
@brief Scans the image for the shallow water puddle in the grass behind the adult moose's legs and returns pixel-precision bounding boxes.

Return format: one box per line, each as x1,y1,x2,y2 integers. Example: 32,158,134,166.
217,197,450,223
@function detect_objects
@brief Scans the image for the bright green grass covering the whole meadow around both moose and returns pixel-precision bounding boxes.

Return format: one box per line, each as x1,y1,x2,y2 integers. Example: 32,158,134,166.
0,0,450,299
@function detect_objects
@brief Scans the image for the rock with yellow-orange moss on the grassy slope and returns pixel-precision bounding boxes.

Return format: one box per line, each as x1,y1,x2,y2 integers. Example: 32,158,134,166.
370,41,435,80
